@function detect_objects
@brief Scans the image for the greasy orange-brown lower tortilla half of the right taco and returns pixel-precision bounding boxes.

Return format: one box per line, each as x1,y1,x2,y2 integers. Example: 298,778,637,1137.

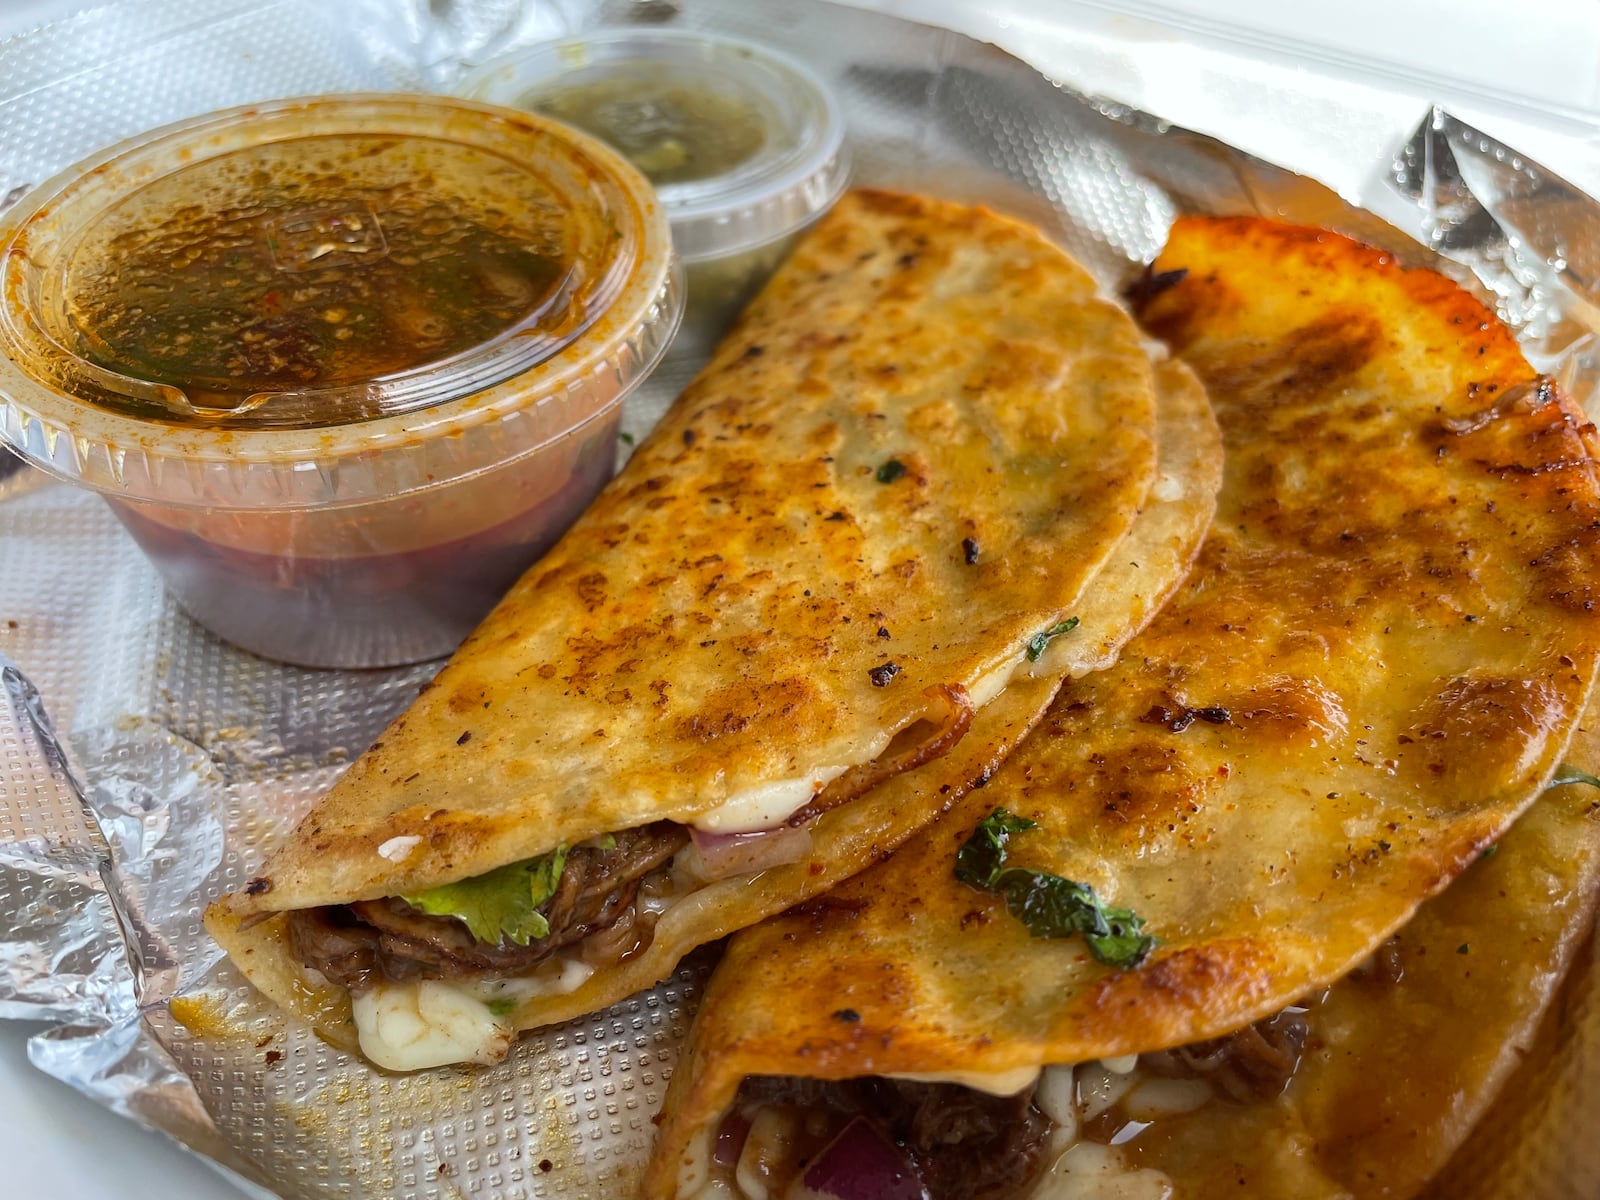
1112,710,1600,1200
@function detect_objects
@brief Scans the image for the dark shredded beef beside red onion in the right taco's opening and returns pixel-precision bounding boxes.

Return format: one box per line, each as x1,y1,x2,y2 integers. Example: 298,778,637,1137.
739,1075,1050,1200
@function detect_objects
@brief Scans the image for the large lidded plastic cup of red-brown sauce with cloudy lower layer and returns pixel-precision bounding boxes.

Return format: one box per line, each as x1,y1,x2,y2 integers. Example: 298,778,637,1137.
0,96,682,667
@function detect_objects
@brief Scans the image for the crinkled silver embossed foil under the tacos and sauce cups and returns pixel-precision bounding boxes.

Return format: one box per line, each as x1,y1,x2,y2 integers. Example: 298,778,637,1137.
0,0,1600,1200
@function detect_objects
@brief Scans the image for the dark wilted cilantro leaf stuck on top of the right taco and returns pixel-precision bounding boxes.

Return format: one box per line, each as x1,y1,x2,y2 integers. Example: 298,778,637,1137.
955,808,1155,966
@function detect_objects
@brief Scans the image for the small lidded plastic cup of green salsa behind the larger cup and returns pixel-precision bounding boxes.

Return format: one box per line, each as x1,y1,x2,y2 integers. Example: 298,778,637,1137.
464,29,850,355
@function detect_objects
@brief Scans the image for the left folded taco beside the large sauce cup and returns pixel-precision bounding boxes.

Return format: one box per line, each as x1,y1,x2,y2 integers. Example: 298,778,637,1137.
208,192,1208,1067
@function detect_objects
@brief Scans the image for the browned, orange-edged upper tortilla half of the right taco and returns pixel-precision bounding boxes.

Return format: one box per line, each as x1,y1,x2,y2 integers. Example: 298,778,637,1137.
645,219,1600,1197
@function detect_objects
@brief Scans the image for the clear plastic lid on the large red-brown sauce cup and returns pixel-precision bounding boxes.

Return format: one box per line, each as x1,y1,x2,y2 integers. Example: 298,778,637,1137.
0,96,682,507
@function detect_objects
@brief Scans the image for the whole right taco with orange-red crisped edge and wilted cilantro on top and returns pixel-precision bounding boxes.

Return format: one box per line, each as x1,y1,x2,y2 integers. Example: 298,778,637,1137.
643,218,1600,1200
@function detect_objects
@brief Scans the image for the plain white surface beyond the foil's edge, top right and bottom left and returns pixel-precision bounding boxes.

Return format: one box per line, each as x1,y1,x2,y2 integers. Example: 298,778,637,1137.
9,0,1600,1200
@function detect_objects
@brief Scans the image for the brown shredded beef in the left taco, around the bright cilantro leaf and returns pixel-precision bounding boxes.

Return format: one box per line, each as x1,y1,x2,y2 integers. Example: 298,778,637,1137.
288,821,690,992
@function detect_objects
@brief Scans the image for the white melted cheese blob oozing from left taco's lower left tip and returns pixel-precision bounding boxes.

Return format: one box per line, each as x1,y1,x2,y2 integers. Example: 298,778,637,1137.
352,979,517,1070
